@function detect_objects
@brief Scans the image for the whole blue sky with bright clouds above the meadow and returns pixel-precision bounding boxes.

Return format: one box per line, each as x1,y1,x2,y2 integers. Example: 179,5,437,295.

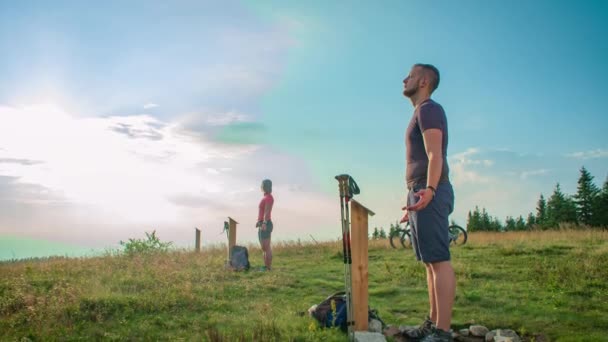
0,1,608,259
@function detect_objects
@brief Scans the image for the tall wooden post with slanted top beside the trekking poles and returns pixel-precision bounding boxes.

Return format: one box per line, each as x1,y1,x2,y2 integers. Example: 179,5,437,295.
350,200,374,331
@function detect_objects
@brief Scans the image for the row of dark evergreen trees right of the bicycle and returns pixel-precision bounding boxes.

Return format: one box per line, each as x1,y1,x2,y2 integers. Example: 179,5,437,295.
467,166,608,232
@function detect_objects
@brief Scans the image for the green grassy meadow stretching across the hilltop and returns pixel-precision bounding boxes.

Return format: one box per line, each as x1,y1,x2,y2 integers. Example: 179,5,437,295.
0,231,608,341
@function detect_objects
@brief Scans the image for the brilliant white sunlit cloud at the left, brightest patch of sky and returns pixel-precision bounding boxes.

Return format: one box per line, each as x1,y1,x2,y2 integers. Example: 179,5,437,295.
0,106,257,227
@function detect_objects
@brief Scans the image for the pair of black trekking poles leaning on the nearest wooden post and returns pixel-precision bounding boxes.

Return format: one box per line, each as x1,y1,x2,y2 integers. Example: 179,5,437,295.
336,174,360,341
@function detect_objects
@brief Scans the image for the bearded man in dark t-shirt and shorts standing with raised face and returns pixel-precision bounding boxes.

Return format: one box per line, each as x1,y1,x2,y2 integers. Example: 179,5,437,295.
401,64,456,342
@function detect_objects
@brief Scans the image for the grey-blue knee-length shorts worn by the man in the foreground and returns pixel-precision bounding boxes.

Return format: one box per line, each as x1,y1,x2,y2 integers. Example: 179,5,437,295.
407,181,454,263
